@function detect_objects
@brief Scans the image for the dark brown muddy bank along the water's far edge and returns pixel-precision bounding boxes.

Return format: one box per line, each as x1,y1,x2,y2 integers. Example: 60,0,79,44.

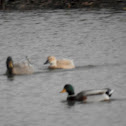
0,0,126,10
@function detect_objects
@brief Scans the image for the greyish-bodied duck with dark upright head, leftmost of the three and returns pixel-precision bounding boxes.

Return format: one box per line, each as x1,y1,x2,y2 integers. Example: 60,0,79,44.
6,56,34,75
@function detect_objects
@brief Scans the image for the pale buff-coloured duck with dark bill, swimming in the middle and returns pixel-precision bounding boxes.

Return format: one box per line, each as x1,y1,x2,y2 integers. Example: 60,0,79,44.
44,56,75,69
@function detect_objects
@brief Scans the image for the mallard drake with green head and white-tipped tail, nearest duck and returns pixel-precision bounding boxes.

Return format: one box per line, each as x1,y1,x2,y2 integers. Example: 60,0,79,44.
60,84,114,102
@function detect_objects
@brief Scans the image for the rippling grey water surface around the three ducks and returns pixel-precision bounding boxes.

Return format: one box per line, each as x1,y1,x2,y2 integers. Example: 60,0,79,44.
0,9,126,126
